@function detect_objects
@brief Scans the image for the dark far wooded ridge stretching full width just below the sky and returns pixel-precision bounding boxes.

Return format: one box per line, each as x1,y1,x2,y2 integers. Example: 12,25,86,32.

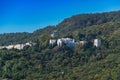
0,11,120,45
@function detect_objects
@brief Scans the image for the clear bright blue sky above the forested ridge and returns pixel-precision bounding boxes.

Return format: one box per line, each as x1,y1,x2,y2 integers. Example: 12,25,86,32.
0,0,120,33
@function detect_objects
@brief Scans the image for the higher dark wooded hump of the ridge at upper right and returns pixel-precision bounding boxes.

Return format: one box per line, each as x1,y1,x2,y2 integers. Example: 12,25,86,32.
58,11,120,30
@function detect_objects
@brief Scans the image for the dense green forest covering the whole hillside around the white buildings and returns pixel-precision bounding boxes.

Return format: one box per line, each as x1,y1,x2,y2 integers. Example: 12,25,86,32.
0,11,120,80
